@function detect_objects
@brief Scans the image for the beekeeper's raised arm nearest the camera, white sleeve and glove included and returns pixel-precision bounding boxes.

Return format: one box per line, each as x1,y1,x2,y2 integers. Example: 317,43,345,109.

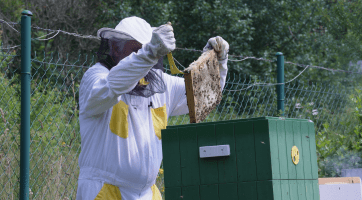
79,25,176,116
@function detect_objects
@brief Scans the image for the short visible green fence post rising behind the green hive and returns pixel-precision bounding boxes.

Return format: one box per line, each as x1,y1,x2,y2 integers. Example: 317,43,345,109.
276,52,284,116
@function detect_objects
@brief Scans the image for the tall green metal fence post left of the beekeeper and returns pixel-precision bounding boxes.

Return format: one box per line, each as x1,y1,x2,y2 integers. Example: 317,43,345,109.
20,10,33,200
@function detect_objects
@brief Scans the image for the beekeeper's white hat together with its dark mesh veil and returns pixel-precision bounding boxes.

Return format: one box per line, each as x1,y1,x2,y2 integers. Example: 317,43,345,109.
97,17,166,97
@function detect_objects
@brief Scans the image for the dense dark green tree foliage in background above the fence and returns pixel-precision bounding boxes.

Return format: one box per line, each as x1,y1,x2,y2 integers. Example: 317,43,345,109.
3,0,362,84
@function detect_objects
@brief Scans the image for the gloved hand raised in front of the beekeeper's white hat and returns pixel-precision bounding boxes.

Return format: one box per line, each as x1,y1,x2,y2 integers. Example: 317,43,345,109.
146,24,176,59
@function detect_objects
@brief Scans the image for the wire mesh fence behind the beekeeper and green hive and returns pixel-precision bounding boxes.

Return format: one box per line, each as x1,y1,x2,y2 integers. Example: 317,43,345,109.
0,45,355,199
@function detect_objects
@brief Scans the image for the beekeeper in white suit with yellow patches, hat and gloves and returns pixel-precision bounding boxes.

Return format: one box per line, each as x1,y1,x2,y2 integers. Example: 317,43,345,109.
77,17,229,200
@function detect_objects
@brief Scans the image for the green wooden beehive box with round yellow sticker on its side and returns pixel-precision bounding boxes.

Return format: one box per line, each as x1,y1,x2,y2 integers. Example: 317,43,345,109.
162,117,319,200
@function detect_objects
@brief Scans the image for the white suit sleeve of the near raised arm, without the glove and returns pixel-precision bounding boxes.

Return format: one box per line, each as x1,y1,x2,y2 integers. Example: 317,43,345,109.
79,47,158,116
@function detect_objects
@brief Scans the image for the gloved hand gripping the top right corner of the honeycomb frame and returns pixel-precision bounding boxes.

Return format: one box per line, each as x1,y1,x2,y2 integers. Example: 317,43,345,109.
203,36,229,61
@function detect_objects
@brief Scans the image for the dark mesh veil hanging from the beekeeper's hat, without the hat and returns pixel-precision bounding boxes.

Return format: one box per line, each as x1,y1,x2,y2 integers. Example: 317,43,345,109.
97,30,166,98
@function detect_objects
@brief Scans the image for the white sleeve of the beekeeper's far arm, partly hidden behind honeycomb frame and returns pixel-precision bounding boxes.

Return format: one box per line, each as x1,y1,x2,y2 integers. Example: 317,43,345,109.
165,58,228,116
